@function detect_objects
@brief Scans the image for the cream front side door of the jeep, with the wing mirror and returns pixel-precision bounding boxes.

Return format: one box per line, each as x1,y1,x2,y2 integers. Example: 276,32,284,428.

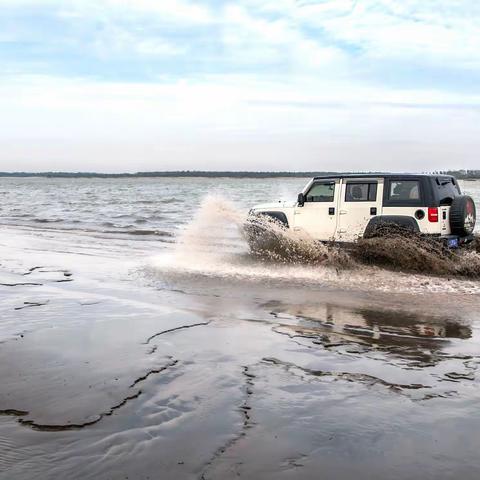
294,178,340,241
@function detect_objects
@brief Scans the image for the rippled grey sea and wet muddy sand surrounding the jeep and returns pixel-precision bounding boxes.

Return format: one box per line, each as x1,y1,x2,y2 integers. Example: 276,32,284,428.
0,179,480,480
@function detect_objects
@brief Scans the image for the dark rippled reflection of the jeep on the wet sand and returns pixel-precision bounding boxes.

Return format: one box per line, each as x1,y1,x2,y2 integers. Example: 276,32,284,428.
264,301,480,400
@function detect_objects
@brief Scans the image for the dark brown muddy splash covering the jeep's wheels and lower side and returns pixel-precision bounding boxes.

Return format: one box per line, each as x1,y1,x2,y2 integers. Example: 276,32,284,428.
246,209,480,279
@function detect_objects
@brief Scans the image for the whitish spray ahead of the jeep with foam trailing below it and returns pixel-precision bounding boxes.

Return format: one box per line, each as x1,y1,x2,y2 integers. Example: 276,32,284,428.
154,196,480,295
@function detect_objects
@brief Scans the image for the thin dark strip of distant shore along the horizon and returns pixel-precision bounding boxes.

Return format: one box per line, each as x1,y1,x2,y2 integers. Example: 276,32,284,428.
0,170,480,180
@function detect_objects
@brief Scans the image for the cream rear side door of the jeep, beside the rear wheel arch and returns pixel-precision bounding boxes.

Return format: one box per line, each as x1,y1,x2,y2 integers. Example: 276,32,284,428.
337,178,383,242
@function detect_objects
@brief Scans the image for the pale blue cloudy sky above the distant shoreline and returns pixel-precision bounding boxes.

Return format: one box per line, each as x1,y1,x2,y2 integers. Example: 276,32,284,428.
0,0,480,172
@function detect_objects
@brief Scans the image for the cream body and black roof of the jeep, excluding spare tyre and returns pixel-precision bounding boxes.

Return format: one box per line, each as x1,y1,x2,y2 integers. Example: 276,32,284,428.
252,174,474,243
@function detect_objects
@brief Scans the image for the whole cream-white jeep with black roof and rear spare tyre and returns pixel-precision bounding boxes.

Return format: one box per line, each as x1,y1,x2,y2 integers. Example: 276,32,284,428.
250,174,476,248
